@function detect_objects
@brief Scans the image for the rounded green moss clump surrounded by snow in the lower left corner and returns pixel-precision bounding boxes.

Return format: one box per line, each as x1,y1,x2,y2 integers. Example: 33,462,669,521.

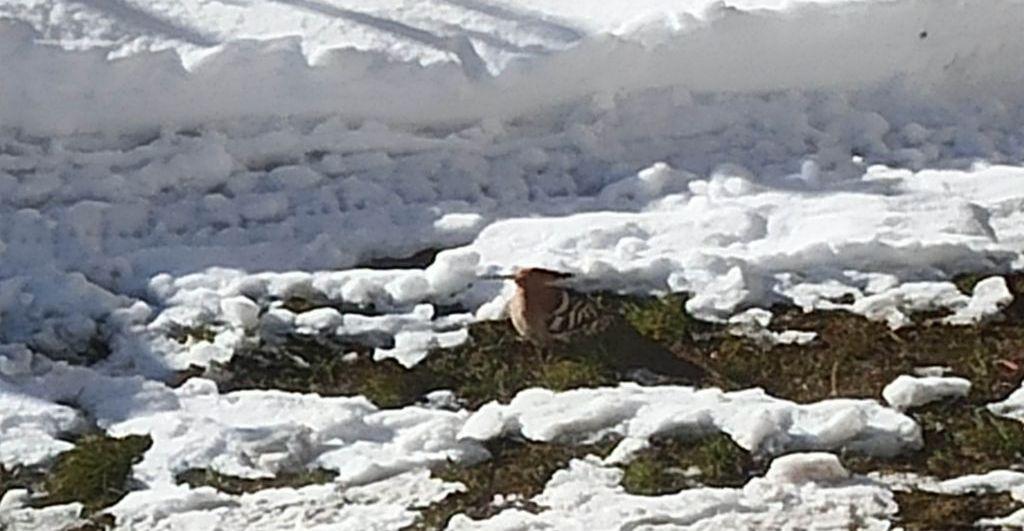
44,435,153,514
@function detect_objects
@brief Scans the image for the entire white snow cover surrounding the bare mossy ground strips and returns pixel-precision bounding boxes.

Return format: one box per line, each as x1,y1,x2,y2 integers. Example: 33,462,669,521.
0,0,1024,529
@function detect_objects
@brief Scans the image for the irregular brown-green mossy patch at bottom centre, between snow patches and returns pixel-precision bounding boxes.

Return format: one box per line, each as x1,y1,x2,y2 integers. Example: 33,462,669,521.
406,439,614,531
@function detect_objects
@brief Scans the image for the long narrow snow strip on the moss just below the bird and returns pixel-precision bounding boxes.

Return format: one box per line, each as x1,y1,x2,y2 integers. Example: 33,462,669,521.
459,384,922,462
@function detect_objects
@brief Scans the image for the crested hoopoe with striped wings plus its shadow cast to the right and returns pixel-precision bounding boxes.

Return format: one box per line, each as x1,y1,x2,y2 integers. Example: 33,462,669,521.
495,267,707,382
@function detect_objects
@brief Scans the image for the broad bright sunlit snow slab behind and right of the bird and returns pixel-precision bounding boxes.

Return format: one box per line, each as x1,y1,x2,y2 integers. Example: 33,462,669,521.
469,172,1022,319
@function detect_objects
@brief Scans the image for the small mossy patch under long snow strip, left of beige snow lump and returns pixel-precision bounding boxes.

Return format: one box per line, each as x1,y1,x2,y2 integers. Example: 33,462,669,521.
623,434,760,495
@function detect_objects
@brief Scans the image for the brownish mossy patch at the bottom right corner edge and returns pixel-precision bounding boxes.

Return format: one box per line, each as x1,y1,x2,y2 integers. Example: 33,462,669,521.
895,490,1018,531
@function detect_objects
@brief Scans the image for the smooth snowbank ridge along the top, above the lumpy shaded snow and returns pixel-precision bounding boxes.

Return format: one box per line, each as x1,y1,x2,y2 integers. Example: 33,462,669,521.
0,0,1024,134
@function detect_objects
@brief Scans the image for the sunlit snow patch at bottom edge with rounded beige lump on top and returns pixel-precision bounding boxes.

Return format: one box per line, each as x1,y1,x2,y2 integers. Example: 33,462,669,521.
449,453,897,531
